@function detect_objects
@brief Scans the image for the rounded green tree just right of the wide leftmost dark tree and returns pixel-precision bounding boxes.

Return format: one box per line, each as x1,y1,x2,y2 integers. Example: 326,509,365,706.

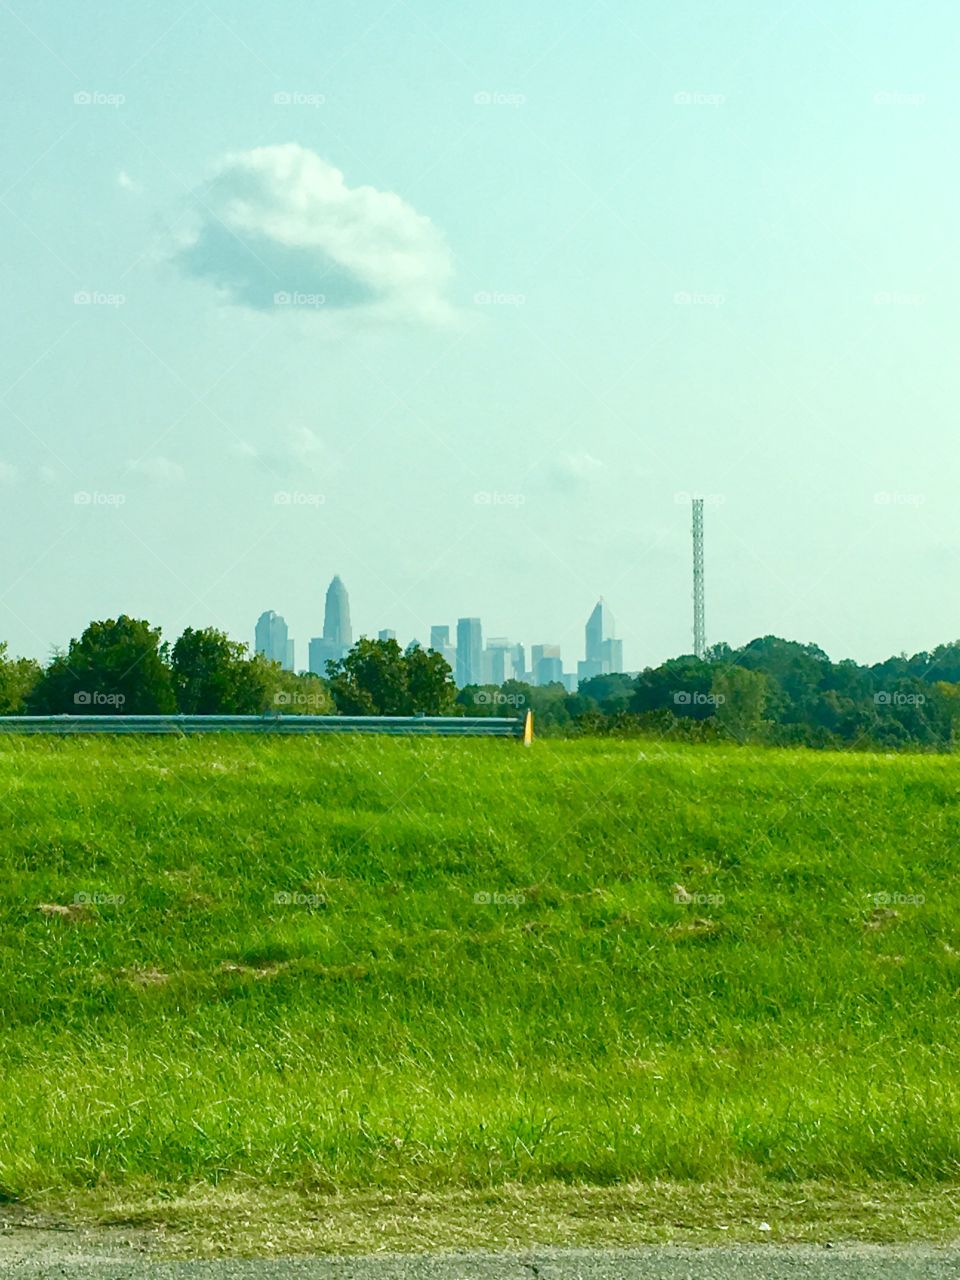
170,627,274,716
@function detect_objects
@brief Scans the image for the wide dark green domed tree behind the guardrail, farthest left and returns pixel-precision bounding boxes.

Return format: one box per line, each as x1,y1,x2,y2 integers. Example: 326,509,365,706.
27,613,177,716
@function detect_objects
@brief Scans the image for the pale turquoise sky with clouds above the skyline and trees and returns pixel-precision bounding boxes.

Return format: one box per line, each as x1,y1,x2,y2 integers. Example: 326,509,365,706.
0,0,960,669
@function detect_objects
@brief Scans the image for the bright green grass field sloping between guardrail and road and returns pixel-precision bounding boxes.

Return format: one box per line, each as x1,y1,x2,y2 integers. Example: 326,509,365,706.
0,737,960,1244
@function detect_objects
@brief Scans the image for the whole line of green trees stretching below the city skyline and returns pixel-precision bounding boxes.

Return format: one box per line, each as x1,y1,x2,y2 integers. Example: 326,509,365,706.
0,614,960,750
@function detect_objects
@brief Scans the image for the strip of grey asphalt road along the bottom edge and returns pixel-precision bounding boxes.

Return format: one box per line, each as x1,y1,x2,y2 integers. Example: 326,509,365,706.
7,1244,960,1280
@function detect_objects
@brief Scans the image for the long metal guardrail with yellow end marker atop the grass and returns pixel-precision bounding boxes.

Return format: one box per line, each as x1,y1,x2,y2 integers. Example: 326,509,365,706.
0,712,534,745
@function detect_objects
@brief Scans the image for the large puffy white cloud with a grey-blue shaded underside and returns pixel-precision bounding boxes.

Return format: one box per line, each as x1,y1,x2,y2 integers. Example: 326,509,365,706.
177,142,453,320
